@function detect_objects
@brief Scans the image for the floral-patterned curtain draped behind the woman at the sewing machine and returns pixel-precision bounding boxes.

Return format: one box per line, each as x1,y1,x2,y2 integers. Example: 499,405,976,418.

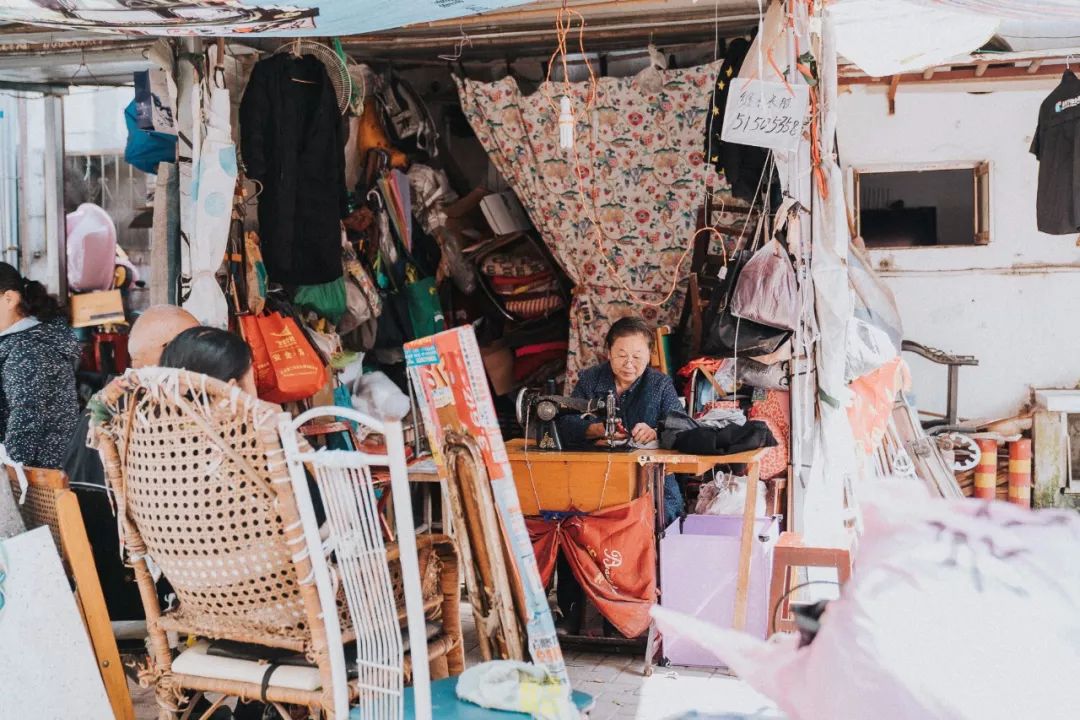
458,63,719,386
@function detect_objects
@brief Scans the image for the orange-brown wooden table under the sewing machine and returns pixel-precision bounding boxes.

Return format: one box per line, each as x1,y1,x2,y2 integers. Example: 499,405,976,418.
507,439,766,675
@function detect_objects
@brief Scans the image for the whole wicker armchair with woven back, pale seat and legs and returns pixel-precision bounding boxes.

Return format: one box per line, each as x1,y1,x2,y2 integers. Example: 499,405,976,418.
92,368,463,720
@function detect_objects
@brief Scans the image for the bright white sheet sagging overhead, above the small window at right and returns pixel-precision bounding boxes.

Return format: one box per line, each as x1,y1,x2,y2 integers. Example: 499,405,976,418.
829,0,1001,78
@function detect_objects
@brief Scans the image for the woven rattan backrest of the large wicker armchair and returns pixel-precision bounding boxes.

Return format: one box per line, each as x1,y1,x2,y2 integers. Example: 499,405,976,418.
99,368,319,651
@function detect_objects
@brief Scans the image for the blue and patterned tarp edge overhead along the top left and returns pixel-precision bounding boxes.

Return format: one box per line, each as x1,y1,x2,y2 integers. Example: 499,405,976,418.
0,0,527,37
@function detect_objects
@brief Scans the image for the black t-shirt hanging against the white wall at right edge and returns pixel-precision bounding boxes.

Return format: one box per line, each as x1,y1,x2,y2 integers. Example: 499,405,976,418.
1031,70,1080,235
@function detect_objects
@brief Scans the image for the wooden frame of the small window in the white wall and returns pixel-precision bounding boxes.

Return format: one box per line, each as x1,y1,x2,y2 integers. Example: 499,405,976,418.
847,160,991,250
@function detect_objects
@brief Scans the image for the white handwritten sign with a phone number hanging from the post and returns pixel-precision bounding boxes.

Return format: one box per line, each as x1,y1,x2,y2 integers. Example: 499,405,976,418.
720,80,810,151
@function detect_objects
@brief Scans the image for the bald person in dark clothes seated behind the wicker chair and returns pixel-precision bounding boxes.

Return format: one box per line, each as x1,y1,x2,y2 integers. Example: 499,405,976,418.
64,305,199,620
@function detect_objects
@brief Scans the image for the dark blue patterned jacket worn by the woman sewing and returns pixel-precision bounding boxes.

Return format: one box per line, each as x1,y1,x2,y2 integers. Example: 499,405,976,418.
558,363,683,447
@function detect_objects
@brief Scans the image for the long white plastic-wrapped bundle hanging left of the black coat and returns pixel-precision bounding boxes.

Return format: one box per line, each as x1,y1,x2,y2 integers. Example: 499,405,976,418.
181,46,237,328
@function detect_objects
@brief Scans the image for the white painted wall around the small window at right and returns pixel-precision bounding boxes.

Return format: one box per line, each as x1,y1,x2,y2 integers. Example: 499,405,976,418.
838,79,1080,418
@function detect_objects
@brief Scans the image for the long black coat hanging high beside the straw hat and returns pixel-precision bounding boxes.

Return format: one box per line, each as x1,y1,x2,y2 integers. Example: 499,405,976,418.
240,54,346,285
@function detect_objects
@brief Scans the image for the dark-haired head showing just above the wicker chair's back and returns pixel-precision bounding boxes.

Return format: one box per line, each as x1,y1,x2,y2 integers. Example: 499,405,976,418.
161,326,256,395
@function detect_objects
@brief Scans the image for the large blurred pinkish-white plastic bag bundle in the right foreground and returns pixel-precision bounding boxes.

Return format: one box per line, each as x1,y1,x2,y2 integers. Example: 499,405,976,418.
653,480,1080,720
